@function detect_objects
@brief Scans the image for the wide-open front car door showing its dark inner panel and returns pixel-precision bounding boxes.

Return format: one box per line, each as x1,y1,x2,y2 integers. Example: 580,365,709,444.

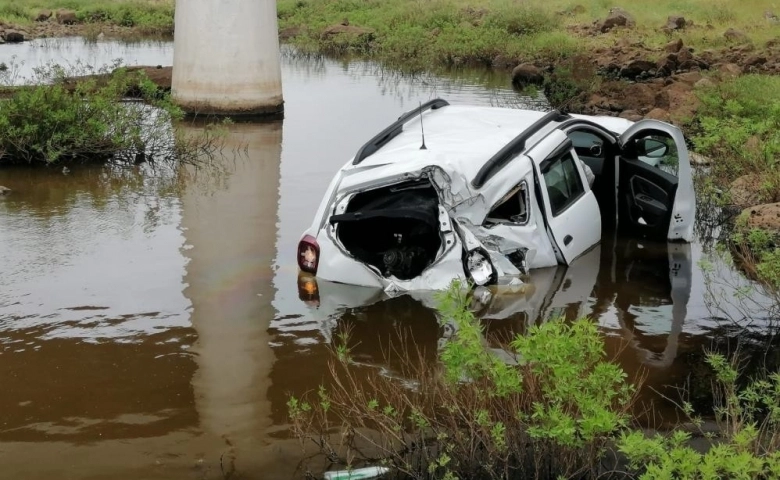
617,120,696,242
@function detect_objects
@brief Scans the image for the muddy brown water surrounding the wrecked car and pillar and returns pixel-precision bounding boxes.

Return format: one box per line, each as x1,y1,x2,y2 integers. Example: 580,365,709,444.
0,39,770,479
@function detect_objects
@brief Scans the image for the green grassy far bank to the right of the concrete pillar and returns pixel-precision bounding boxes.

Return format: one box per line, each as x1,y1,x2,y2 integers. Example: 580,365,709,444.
278,0,776,69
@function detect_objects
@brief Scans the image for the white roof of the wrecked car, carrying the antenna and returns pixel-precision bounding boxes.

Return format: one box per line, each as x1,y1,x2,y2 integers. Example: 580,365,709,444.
342,103,633,188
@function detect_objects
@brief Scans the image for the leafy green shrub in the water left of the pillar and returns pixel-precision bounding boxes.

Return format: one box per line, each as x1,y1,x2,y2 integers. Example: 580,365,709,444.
0,67,182,164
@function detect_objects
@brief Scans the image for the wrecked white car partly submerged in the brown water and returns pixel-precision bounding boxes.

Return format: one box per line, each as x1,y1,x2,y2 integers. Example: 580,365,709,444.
297,99,695,293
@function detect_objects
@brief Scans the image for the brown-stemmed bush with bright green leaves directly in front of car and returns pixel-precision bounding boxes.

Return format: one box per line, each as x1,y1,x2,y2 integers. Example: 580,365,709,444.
288,284,634,479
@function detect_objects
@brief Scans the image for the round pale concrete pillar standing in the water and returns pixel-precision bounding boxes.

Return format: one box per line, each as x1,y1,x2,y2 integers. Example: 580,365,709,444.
172,0,283,115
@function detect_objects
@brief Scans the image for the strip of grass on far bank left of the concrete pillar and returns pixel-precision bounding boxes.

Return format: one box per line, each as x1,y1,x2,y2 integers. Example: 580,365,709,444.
0,0,174,35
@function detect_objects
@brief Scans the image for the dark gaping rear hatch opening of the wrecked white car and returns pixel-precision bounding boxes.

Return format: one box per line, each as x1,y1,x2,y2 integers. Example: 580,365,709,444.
330,179,441,280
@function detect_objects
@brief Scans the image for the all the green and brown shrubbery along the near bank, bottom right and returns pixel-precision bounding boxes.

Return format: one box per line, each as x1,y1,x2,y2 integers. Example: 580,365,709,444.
287,284,780,480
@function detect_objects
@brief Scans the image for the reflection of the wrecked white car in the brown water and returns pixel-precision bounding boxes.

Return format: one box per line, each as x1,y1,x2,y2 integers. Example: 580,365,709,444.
299,235,692,408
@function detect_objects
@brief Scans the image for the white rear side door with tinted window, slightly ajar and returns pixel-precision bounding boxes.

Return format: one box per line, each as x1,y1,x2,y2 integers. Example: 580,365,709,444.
537,137,601,265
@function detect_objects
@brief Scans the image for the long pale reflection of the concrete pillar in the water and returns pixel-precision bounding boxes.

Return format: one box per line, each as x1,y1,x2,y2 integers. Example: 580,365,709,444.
182,122,282,472
